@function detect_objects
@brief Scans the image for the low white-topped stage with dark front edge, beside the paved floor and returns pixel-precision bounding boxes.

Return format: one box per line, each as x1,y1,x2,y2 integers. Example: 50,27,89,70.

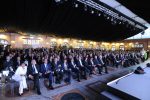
107,67,150,100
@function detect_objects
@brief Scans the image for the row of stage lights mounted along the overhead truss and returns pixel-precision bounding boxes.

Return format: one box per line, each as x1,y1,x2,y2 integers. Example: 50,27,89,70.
55,0,145,30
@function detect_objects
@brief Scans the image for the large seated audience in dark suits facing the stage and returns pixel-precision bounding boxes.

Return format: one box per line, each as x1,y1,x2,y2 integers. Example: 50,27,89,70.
0,48,144,95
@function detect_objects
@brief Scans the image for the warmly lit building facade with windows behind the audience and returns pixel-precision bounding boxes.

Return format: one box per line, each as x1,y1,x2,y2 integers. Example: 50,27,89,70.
0,33,150,50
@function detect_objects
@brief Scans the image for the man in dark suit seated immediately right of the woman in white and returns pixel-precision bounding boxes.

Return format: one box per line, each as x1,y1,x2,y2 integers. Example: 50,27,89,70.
27,59,41,95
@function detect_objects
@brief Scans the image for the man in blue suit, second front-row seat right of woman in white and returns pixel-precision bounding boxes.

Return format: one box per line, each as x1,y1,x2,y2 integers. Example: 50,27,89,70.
40,59,54,89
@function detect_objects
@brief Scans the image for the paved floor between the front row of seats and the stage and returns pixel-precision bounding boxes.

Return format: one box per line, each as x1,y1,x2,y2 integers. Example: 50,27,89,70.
0,59,150,100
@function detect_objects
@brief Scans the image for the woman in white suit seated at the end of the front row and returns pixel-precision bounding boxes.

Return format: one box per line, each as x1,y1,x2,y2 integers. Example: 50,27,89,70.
12,62,28,96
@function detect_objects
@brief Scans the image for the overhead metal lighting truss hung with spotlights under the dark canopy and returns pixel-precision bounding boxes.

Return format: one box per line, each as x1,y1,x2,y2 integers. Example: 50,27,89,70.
55,0,147,30
